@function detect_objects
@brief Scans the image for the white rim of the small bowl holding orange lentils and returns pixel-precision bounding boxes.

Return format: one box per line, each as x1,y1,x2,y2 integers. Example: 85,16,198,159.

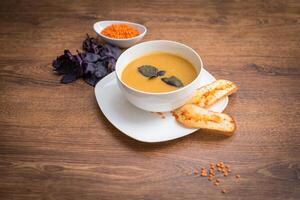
94,20,147,41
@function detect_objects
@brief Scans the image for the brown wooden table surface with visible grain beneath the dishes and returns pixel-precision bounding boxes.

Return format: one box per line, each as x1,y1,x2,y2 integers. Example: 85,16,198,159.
0,0,300,200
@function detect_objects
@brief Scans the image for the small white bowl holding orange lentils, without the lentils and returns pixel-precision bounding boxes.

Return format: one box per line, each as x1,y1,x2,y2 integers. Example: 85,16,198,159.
94,21,147,48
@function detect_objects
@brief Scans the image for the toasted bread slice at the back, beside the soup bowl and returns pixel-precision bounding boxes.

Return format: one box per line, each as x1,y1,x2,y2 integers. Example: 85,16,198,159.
187,80,238,108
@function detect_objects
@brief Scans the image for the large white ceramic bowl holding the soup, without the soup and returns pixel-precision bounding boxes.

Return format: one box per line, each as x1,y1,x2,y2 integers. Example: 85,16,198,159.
116,40,203,112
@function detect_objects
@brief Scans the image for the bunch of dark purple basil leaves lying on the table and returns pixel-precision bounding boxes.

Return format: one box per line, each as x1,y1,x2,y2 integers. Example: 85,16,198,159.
52,35,121,86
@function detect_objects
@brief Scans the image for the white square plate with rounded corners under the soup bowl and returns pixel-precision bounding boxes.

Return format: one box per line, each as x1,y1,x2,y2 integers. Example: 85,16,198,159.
95,69,228,142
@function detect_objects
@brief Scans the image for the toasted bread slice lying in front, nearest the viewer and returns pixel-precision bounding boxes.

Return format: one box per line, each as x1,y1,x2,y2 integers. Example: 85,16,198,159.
173,104,236,136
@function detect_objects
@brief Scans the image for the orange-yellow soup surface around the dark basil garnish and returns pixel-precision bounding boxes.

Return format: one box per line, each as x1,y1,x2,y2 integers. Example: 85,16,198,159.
121,52,197,93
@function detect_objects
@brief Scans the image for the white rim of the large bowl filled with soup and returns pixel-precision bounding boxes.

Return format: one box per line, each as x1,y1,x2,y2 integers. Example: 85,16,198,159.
115,40,203,96
